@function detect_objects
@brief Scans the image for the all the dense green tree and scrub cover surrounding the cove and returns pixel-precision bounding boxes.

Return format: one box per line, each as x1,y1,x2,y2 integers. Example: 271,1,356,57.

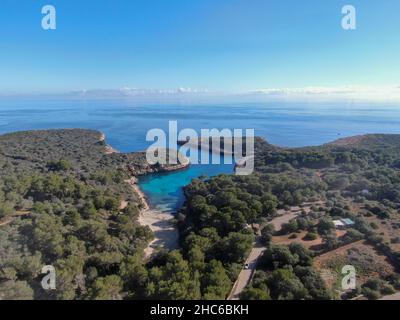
0,130,400,299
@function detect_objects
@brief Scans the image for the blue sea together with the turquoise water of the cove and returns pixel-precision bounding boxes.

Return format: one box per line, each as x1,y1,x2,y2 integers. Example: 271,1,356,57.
0,98,400,211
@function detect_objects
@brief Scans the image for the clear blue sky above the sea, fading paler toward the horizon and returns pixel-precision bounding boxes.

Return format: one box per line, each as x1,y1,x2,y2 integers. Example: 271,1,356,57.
0,0,400,100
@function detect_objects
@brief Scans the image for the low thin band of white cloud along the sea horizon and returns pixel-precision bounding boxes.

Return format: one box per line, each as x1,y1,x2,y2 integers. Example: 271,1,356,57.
30,85,400,102
